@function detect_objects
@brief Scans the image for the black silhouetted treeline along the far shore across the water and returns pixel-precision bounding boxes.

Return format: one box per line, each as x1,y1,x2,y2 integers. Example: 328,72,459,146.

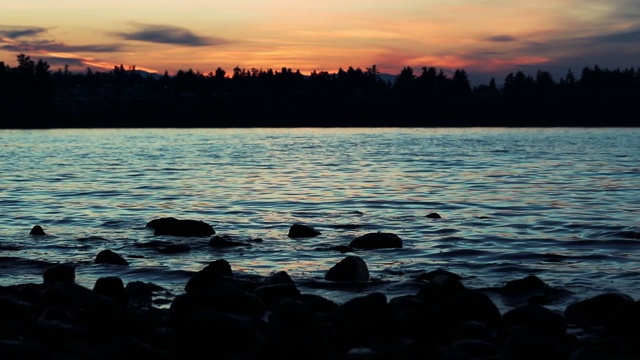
0,54,640,128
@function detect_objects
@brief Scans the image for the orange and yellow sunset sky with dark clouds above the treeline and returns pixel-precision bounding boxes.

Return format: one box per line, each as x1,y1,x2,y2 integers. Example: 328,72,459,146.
0,0,640,83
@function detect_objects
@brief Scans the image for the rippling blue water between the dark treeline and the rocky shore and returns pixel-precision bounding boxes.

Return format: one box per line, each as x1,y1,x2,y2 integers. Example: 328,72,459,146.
0,128,640,308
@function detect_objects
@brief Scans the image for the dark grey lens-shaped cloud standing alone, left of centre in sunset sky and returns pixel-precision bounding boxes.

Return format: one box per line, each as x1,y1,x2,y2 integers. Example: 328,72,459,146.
117,23,229,46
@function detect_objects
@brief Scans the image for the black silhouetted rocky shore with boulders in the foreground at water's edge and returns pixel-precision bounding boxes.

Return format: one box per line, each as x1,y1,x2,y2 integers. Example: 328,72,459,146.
0,223,640,360
